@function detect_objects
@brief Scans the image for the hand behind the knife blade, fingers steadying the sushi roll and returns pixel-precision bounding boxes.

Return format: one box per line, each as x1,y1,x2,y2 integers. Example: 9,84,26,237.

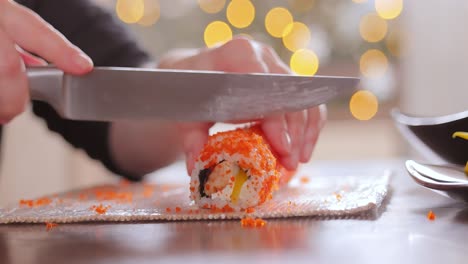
159,37,326,172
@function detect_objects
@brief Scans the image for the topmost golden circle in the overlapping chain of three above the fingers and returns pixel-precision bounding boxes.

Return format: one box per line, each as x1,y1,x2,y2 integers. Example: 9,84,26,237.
265,7,293,38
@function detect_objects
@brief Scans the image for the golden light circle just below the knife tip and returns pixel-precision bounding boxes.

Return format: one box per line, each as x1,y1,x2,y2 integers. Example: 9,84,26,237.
349,90,379,121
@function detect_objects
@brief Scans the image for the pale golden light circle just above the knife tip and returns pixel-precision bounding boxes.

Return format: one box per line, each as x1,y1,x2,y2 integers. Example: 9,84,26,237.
359,49,388,78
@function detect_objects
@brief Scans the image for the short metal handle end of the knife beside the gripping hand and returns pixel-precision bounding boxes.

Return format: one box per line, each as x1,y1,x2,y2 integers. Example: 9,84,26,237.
26,66,64,110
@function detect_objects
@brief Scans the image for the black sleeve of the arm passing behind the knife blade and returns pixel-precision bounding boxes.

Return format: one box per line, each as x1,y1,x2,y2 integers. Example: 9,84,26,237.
18,0,150,180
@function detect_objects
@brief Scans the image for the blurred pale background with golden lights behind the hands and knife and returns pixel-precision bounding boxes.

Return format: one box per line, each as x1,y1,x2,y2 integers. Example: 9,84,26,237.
0,0,468,206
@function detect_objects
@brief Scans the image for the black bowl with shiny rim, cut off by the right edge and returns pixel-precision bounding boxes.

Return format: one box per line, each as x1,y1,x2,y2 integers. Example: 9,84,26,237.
392,110,468,165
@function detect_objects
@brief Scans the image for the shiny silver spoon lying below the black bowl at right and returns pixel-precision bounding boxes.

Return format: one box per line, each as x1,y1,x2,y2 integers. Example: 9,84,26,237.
405,160,468,202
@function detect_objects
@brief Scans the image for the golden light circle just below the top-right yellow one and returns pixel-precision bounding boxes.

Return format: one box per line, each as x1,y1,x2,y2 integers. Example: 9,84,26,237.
359,14,388,42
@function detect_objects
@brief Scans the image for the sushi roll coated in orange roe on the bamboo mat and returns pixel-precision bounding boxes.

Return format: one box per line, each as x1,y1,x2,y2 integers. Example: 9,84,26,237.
190,126,292,211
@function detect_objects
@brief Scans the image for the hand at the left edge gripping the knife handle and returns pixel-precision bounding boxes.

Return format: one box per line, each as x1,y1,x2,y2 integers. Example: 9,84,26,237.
0,0,93,125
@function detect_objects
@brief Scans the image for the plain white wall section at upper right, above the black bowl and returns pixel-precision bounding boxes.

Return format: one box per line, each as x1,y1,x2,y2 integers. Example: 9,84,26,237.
401,0,468,116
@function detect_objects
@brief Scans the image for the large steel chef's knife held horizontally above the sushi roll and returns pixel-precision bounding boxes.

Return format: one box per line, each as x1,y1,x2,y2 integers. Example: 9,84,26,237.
27,67,359,122
